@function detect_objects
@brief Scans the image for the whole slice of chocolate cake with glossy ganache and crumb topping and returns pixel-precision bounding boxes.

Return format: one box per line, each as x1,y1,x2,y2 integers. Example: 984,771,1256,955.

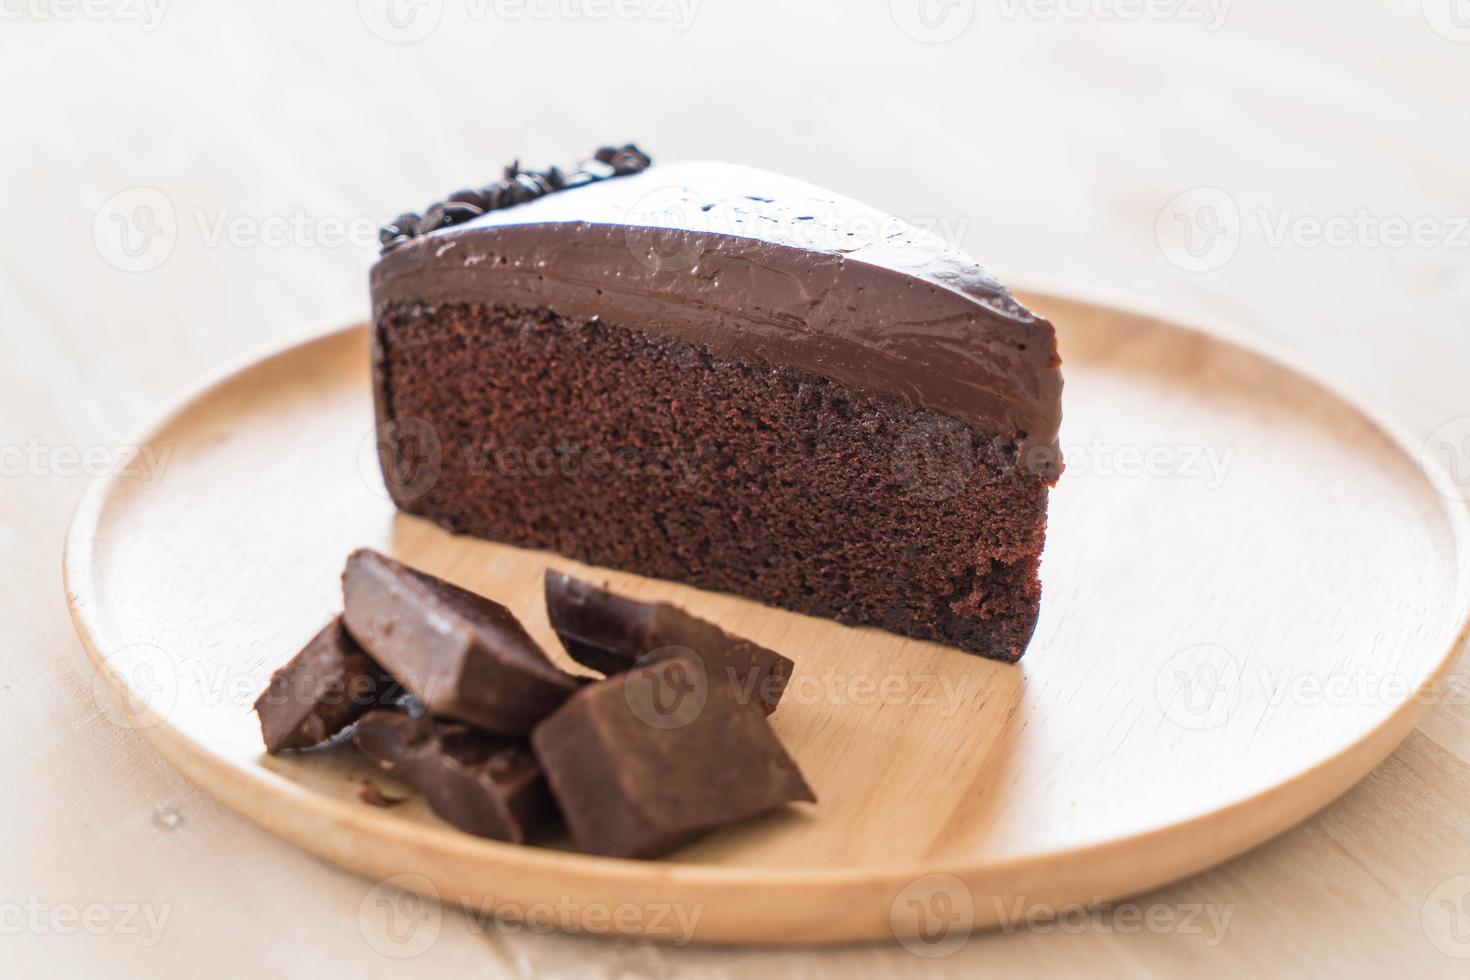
372,148,1061,660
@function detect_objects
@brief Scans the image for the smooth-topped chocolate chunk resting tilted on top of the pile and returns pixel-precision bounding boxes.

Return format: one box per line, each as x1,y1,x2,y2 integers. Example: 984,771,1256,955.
343,550,581,735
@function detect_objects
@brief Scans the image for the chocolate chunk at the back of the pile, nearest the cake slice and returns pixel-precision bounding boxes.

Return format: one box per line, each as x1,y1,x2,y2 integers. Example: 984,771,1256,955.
545,569,795,714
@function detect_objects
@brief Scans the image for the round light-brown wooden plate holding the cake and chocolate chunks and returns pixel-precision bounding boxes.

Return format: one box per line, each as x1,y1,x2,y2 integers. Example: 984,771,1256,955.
66,295,1470,951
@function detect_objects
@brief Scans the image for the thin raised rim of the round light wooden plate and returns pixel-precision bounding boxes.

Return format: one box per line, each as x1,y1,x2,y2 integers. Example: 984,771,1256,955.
63,284,1470,928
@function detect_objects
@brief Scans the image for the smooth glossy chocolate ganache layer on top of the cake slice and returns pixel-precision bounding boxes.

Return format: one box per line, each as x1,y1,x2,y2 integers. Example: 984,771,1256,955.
372,162,1061,470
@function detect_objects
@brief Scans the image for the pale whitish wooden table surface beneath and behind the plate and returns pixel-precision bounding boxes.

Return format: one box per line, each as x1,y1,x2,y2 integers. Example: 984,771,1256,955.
0,0,1470,977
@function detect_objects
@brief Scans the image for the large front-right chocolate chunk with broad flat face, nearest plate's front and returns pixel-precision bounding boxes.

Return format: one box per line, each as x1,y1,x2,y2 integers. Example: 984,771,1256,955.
531,657,816,858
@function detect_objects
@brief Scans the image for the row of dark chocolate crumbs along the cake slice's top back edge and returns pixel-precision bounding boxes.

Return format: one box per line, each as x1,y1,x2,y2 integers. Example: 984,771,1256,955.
378,143,653,256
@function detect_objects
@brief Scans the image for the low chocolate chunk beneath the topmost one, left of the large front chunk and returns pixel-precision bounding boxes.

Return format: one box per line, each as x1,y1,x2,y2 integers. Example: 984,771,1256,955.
353,711,556,843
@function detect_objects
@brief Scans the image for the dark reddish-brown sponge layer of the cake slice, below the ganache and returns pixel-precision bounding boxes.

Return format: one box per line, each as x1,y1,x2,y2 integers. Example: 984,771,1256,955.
375,304,1048,660
